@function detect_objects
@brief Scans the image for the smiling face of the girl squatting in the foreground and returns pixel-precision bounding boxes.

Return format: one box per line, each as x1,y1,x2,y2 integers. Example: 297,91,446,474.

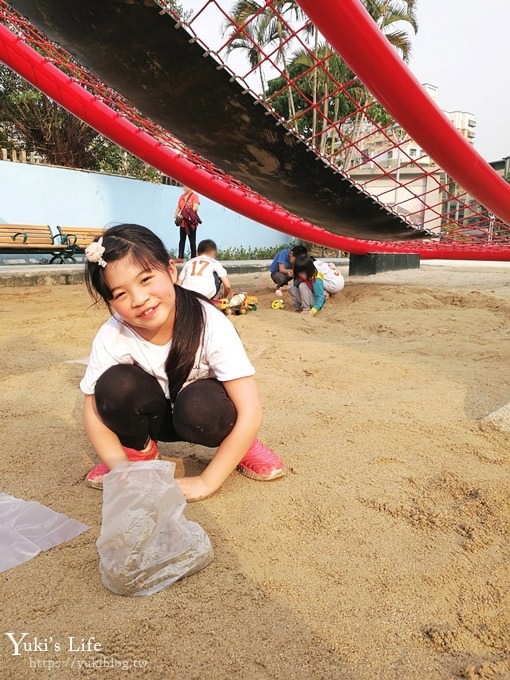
105,256,177,344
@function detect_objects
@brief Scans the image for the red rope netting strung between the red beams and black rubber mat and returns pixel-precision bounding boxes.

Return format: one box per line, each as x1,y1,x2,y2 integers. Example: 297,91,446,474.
0,0,510,250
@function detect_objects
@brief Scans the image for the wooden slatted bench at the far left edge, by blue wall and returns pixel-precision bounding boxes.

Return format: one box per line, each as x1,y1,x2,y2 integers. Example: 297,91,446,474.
0,224,75,264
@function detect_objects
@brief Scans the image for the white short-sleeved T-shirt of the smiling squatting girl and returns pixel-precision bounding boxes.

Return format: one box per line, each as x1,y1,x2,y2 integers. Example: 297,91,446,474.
80,302,255,399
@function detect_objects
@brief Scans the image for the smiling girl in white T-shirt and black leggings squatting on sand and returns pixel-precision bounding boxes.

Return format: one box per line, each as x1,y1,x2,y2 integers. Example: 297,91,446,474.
80,224,284,500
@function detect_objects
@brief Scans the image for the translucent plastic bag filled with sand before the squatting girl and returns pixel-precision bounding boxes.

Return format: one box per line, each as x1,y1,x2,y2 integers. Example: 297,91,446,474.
97,460,213,595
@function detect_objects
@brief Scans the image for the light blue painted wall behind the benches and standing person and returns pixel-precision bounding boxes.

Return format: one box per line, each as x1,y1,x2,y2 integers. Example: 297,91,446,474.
0,161,292,250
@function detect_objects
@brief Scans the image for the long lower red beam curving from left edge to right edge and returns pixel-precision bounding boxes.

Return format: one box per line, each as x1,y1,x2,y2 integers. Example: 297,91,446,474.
0,24,510,260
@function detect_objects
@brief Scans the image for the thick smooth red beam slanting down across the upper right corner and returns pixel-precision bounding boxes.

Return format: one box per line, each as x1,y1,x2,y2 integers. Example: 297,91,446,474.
297,0,510,224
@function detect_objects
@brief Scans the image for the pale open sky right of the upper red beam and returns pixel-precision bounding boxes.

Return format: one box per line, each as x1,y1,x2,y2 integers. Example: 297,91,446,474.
409,0,510,161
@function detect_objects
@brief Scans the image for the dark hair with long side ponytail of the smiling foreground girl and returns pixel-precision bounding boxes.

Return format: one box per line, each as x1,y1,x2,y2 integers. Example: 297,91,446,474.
85,224,207,401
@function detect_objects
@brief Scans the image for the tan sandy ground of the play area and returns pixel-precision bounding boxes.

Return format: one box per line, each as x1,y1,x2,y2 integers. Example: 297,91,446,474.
0,268,510,680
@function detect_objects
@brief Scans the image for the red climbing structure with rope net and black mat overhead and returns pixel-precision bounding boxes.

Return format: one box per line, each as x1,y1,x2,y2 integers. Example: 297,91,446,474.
0,0,510,260
